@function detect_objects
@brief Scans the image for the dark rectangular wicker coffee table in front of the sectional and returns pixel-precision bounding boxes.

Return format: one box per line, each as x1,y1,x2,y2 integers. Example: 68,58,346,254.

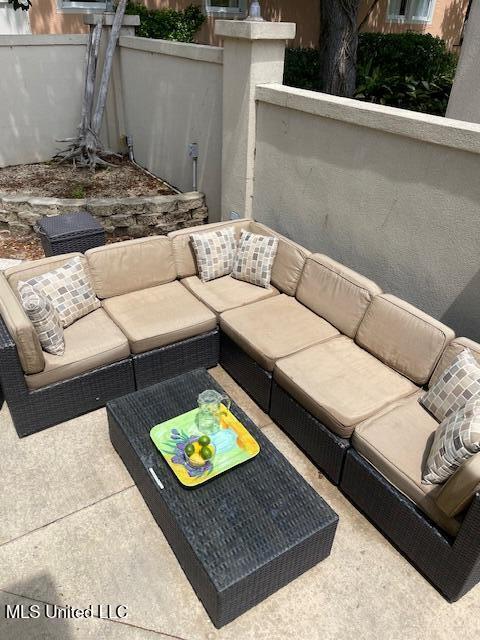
107,369,338,627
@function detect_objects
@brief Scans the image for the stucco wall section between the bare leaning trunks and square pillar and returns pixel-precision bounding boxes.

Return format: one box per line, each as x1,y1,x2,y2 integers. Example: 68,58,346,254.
120,37,223,220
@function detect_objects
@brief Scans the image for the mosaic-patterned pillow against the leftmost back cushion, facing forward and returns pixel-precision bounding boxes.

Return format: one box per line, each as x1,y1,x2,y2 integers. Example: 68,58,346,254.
23,257,100,328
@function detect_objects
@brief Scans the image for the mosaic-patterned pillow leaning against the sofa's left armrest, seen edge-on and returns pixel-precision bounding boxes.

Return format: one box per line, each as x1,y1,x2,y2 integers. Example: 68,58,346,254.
17,282,65,356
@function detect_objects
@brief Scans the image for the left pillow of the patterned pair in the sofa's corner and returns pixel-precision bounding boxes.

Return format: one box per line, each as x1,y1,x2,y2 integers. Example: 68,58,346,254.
190,227,237,282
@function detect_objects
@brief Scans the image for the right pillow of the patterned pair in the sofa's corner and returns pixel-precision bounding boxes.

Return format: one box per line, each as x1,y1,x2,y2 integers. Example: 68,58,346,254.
232,231,278,289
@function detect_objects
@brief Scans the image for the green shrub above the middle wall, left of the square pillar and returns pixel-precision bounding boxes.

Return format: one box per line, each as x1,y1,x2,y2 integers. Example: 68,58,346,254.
126,2,205,42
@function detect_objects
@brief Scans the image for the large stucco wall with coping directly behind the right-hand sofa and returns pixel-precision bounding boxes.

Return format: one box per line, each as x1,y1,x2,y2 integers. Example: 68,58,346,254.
254,85,480,340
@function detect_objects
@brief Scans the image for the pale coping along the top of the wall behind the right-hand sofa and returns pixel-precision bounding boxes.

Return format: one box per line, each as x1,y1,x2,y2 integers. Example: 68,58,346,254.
255,84,480,154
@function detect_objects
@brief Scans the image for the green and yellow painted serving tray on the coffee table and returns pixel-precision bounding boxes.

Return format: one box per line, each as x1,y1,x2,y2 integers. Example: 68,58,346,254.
150,405,260,487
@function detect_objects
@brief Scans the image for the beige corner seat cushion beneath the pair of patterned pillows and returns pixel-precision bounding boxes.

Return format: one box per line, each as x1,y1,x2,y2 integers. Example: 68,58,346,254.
182,276,278,315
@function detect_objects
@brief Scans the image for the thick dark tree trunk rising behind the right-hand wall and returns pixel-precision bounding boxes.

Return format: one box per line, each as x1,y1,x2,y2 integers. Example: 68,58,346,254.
320,0,360,97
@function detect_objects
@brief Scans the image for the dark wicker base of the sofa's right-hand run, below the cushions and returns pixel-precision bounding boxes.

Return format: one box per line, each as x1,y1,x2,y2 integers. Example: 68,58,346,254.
220,334,480,602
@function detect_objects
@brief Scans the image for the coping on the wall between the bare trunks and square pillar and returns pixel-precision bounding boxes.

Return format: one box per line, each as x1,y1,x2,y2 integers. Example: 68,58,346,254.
120,36,223,64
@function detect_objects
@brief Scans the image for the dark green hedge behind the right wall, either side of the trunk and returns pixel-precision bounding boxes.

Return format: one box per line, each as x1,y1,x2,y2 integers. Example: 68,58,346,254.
284,32,457,116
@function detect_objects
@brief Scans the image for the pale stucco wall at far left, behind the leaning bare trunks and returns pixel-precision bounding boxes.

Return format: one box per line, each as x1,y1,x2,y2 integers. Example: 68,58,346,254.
0,35,86,166
